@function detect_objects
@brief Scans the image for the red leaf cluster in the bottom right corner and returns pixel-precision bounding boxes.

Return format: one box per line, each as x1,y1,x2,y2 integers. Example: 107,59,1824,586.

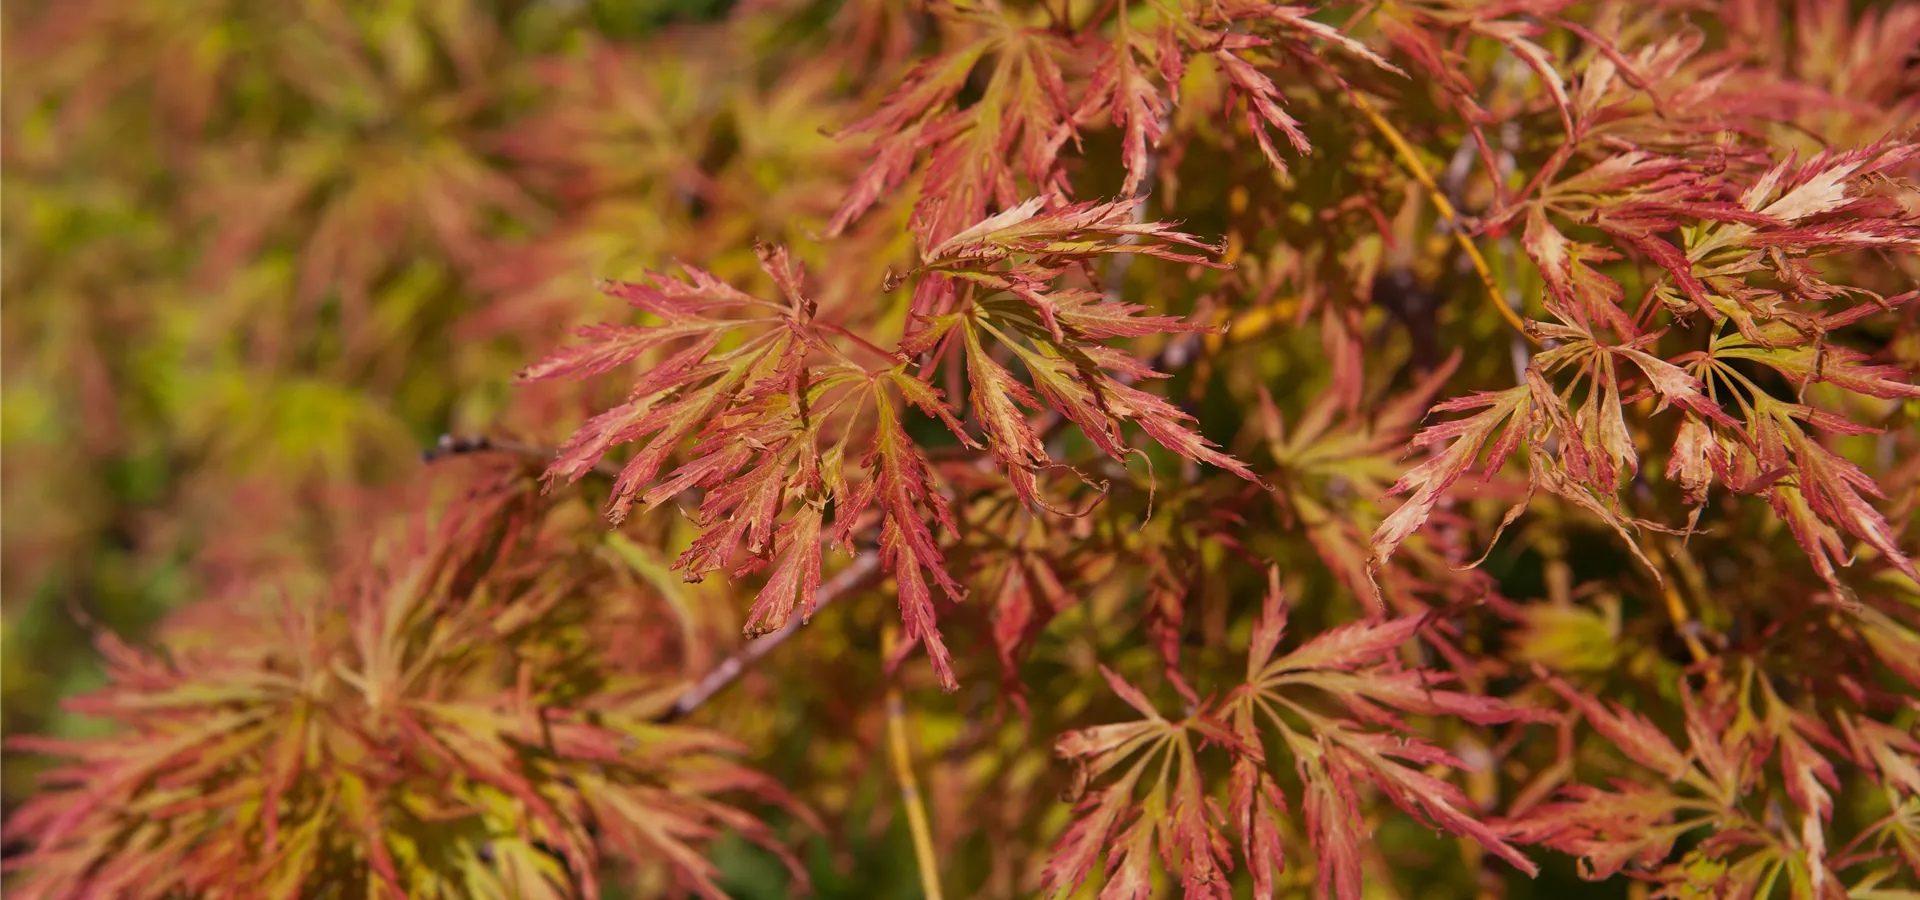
1501,656,1920,898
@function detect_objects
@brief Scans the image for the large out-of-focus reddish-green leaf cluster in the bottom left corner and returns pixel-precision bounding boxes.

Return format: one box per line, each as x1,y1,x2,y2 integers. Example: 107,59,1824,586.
6,466,801,900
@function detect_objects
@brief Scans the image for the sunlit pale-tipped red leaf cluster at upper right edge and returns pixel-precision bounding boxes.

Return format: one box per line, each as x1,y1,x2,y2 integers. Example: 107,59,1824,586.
1375,144,1920,595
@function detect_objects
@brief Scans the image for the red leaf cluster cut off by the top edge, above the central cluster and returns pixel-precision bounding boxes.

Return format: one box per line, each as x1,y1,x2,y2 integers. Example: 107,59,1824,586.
829,2,1398,244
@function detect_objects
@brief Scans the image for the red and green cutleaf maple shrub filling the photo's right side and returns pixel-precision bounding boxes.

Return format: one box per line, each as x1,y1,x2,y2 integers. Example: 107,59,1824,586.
4,0,1920,900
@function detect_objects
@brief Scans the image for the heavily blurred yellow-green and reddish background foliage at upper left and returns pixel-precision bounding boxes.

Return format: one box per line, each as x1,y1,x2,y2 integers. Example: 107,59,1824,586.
0,0,779,817
